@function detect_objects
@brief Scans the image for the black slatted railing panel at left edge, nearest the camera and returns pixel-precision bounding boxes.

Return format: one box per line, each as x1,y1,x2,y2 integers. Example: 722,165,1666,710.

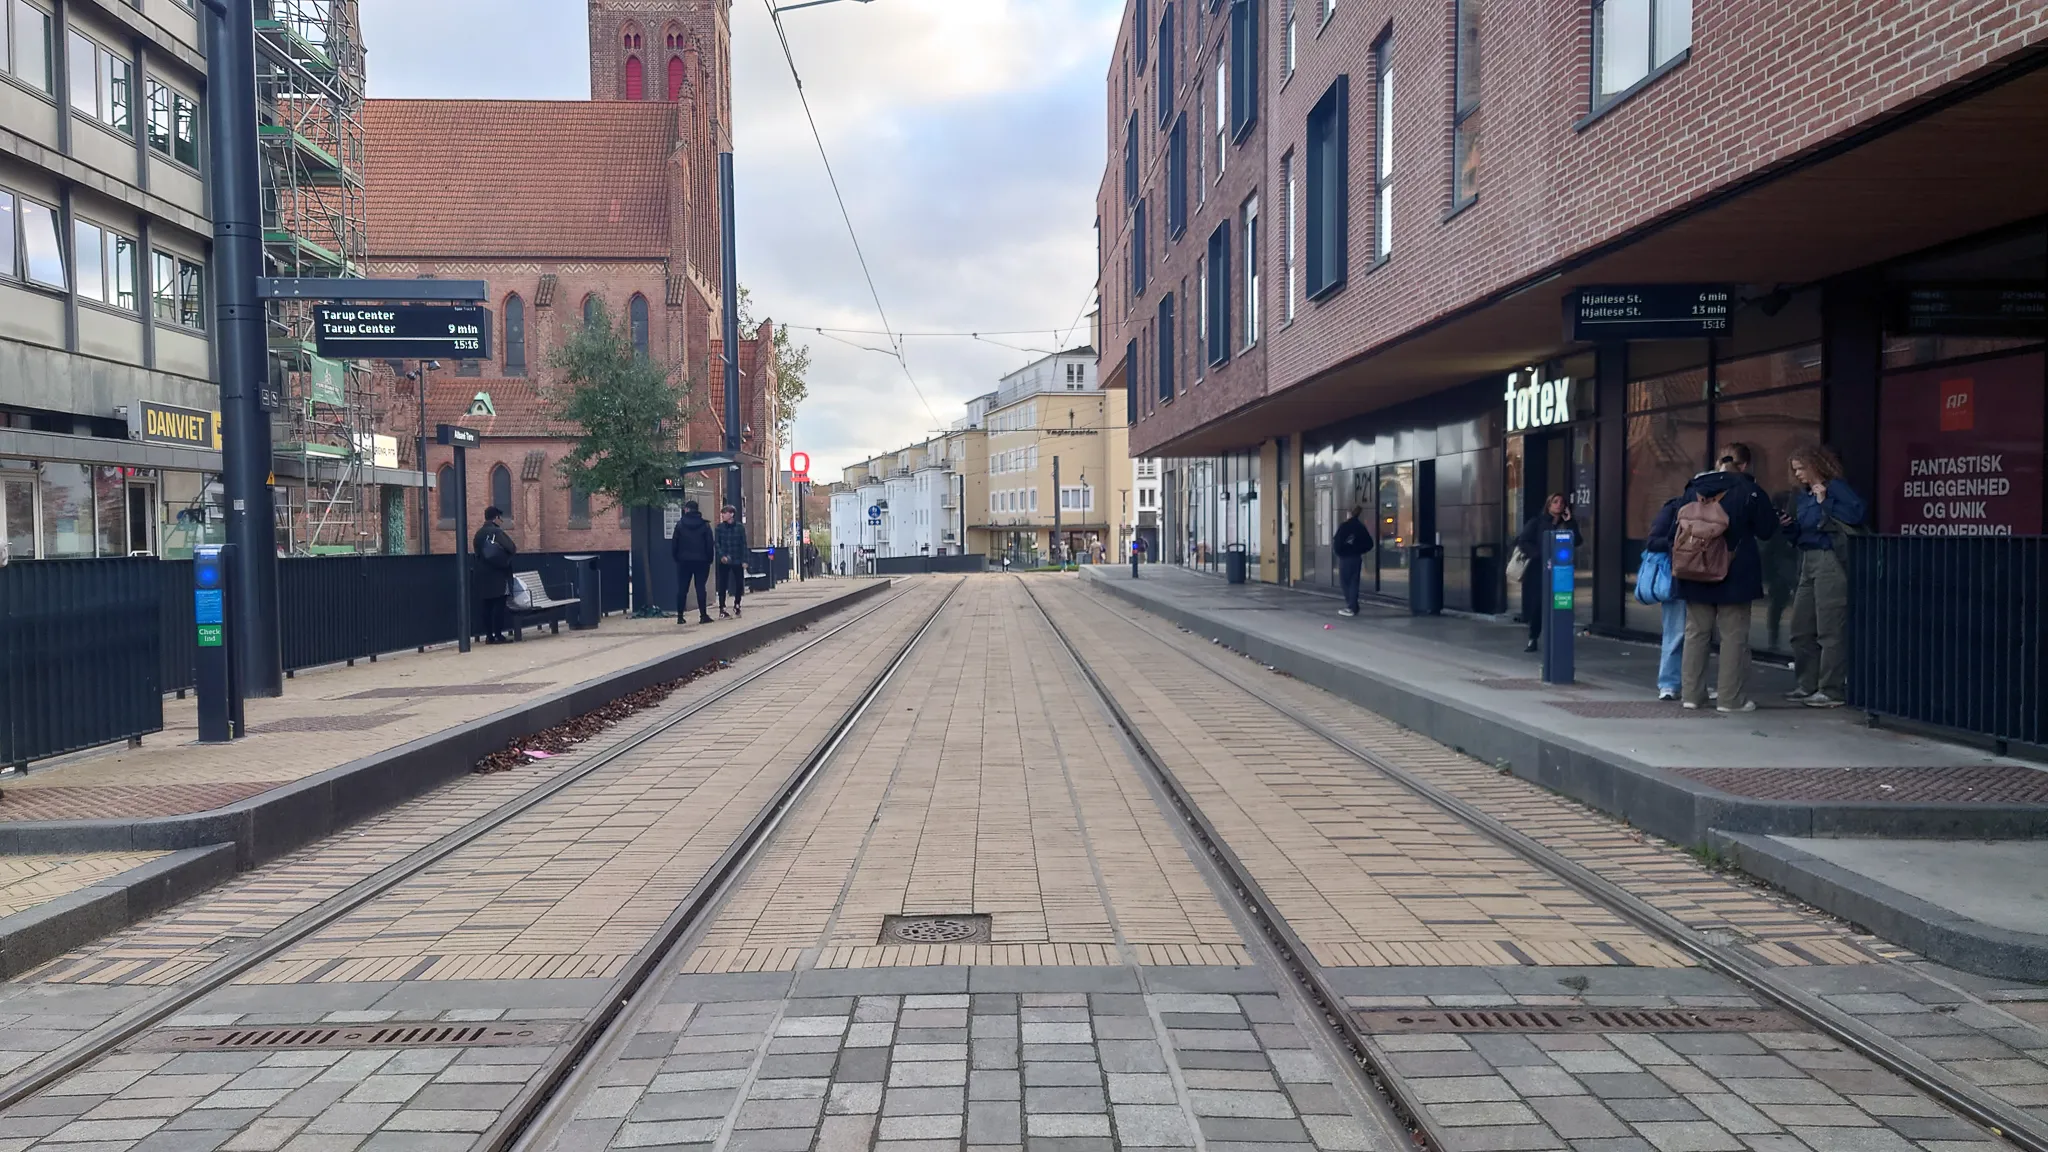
0,560,163,765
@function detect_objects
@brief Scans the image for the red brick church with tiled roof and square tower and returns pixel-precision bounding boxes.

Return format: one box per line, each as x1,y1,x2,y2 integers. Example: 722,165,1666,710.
365,0,778,551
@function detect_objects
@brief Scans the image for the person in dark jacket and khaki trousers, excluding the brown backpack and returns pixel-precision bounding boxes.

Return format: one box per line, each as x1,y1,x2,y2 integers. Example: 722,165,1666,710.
1671,445,1778,711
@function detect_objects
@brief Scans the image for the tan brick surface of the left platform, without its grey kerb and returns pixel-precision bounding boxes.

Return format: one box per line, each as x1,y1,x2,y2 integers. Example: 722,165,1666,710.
0,580,848,824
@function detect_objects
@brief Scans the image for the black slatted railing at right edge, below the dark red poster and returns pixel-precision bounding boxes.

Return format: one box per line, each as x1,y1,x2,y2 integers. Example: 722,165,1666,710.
1847,537,2048,744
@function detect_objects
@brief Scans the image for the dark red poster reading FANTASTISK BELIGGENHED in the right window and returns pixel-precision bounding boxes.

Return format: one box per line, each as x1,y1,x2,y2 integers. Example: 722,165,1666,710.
1878,353,2044,535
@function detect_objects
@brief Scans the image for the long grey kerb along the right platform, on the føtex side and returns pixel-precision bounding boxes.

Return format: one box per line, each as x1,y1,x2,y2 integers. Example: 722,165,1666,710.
1083,570,2048,845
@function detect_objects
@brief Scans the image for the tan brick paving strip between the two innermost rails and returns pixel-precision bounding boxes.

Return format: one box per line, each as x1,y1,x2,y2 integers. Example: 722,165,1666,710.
688,580,1249,972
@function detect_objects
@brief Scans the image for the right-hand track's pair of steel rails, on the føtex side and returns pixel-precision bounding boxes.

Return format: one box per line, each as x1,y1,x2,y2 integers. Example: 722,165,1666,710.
1020,578,2048,1152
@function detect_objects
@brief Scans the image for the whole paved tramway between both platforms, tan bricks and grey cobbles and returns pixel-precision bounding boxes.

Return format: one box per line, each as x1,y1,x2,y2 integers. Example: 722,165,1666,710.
0,576,2048,1152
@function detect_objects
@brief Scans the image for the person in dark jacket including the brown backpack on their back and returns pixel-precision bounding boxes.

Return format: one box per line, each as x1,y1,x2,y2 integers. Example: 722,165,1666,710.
1671,445,1778,711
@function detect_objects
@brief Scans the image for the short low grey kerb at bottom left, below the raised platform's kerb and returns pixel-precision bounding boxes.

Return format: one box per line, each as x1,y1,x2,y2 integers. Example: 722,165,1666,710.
0,845,236,980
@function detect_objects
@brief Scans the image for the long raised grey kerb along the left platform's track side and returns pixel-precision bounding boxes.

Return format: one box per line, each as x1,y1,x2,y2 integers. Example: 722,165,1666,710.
0,580,891,860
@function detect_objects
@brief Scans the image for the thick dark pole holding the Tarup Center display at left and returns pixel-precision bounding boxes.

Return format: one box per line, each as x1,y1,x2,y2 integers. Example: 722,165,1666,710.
205,0,285,697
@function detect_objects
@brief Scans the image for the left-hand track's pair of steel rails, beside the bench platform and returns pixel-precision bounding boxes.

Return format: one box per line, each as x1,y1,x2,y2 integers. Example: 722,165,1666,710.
0,573,952,1132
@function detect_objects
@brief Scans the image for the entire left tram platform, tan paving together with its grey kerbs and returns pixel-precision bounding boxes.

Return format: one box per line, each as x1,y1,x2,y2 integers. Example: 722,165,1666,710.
0,580,885,974
